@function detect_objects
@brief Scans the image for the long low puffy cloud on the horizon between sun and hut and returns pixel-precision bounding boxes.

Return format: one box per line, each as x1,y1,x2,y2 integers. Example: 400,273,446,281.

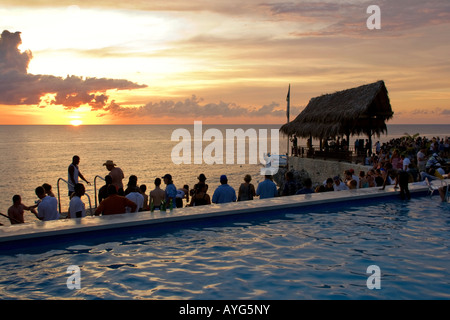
99,95,300,118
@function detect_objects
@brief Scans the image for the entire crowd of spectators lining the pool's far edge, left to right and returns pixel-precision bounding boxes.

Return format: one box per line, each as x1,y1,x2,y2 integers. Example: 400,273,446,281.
3,137,449,224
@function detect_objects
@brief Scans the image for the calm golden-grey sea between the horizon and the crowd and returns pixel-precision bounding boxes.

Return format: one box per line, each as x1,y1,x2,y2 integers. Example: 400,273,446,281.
0,125,450,225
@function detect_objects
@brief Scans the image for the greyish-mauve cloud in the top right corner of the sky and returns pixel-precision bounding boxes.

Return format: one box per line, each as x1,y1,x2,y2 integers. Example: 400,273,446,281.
259,0,450,37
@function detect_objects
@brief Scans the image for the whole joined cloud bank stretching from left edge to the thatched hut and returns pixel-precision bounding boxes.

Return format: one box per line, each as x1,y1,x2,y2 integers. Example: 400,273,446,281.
0,30,300,118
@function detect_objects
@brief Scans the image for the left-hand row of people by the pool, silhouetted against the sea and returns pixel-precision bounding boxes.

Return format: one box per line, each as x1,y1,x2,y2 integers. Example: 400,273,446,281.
1,156,278,224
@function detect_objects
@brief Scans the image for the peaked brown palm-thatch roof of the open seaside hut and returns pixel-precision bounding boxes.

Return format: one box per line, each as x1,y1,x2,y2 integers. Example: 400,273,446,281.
280,81,394,139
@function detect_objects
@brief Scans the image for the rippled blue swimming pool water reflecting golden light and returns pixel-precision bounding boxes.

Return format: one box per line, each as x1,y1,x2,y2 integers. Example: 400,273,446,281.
0,196,450,300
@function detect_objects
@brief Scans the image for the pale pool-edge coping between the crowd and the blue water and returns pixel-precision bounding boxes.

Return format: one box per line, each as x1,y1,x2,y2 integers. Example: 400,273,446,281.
0,180,442,243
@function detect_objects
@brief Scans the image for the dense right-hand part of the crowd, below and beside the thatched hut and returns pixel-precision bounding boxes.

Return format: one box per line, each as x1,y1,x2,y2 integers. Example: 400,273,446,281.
282,136,450,201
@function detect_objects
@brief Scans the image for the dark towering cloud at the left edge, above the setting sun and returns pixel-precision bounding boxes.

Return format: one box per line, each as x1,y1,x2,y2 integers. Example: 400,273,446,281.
0,30,147,110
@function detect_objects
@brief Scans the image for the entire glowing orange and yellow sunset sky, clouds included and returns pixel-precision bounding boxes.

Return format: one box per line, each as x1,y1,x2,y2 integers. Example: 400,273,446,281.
0,0,450,124
